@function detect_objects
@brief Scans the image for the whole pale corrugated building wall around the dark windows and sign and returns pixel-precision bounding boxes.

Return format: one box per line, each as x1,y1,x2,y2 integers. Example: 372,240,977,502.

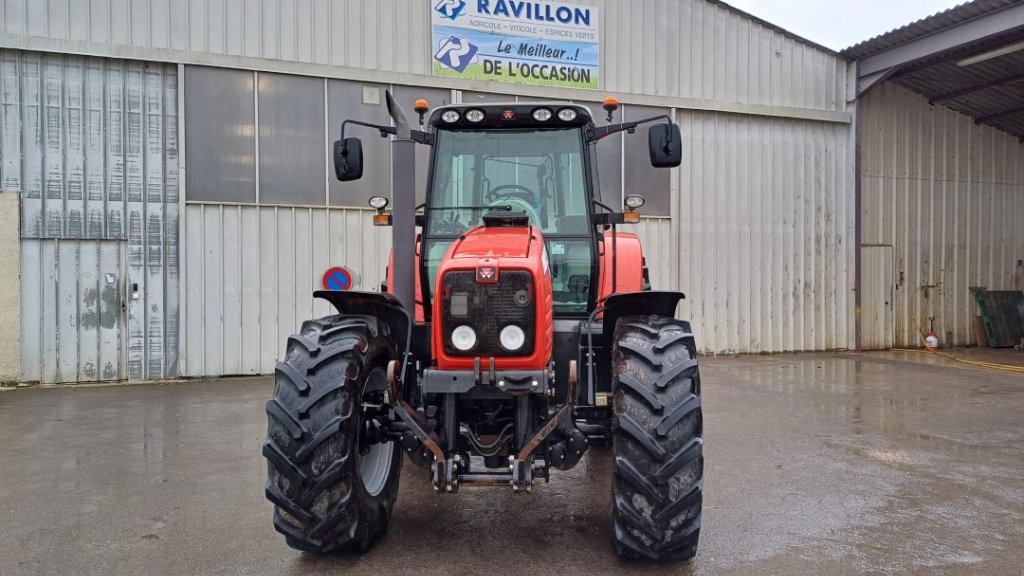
0,0,854,376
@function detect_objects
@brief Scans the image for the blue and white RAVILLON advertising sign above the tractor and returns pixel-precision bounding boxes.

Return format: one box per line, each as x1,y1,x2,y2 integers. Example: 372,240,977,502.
430,0,600,90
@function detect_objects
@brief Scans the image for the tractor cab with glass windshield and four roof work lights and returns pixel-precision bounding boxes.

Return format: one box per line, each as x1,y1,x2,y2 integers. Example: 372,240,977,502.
421,102,600,317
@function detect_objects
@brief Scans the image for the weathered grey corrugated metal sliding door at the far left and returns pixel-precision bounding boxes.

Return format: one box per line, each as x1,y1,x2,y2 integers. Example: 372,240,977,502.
0,50,178,381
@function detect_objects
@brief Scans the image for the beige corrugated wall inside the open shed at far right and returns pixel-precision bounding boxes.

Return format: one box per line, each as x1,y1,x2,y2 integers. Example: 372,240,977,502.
860,83,1024,346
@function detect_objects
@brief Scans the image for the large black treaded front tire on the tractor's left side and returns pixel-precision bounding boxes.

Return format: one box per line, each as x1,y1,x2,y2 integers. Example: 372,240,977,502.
263,316,401,553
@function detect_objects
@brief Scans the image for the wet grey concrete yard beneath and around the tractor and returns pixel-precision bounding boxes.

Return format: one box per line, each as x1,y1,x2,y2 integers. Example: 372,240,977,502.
0,352,1024,575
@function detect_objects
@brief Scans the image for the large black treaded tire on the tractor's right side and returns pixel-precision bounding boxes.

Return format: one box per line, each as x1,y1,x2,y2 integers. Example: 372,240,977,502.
611,316,703,561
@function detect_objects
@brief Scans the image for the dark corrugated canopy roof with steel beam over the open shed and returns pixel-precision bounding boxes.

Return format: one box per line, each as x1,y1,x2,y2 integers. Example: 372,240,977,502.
842,0,1024,141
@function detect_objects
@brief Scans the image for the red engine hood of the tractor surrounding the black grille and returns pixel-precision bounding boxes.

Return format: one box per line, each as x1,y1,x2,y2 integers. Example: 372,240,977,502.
431,227,554,370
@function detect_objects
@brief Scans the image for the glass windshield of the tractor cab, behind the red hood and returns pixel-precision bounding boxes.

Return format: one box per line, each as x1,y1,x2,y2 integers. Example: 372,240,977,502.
425,128,593,315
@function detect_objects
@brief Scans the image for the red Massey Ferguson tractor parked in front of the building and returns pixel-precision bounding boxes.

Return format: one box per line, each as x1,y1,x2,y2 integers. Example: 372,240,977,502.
263,94,703,561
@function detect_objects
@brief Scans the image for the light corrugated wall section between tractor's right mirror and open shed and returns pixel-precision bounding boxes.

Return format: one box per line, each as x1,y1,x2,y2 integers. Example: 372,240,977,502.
663,107,854,353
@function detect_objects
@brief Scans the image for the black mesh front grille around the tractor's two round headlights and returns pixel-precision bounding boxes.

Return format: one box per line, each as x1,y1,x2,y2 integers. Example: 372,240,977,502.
441,271,537,358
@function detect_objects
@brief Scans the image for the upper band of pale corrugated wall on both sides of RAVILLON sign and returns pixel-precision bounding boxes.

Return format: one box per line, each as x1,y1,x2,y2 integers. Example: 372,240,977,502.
0,0,847,113
